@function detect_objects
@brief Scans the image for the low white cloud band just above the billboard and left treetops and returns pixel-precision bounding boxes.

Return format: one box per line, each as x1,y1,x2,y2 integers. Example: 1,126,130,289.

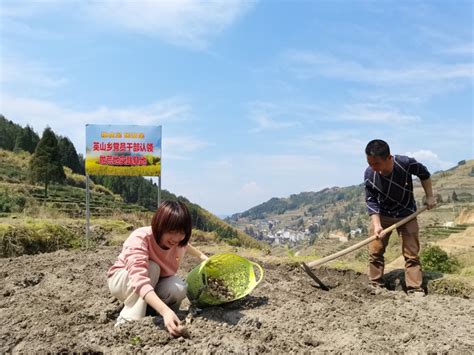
0,94,191,153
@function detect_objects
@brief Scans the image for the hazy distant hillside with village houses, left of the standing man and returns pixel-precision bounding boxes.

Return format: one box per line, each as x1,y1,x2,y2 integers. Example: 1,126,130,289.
226,185,367,244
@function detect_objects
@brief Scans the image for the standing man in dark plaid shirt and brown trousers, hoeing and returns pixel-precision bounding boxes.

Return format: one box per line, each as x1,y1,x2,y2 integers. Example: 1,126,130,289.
364,139,435,295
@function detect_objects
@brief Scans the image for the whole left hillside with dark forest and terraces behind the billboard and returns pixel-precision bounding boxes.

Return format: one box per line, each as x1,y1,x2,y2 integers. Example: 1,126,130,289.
0,114,261,247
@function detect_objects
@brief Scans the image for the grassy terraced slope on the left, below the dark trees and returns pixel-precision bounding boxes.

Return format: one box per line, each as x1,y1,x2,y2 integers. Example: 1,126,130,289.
0,149,262,248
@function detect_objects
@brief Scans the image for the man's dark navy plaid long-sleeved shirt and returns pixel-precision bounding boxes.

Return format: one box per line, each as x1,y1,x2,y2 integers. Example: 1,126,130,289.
364,155,430,218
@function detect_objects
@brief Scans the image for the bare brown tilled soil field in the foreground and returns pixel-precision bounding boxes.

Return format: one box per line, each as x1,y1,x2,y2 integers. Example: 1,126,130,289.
0,247,474,354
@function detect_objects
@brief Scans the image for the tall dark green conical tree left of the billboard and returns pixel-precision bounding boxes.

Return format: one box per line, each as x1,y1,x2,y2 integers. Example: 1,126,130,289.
30,127,66,197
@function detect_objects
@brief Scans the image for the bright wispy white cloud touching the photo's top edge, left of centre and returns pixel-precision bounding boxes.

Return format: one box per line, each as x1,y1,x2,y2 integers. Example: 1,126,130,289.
86,0,255,49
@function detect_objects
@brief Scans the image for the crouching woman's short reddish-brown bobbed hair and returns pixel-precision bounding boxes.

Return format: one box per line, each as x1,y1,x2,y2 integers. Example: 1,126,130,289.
151,201,192,246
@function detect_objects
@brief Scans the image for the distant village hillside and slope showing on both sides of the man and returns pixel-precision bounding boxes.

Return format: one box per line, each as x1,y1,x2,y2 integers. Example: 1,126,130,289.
226,160,474,244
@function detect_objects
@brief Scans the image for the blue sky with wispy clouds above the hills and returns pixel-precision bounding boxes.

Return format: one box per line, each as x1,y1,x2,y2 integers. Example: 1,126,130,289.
0,0,474,215
